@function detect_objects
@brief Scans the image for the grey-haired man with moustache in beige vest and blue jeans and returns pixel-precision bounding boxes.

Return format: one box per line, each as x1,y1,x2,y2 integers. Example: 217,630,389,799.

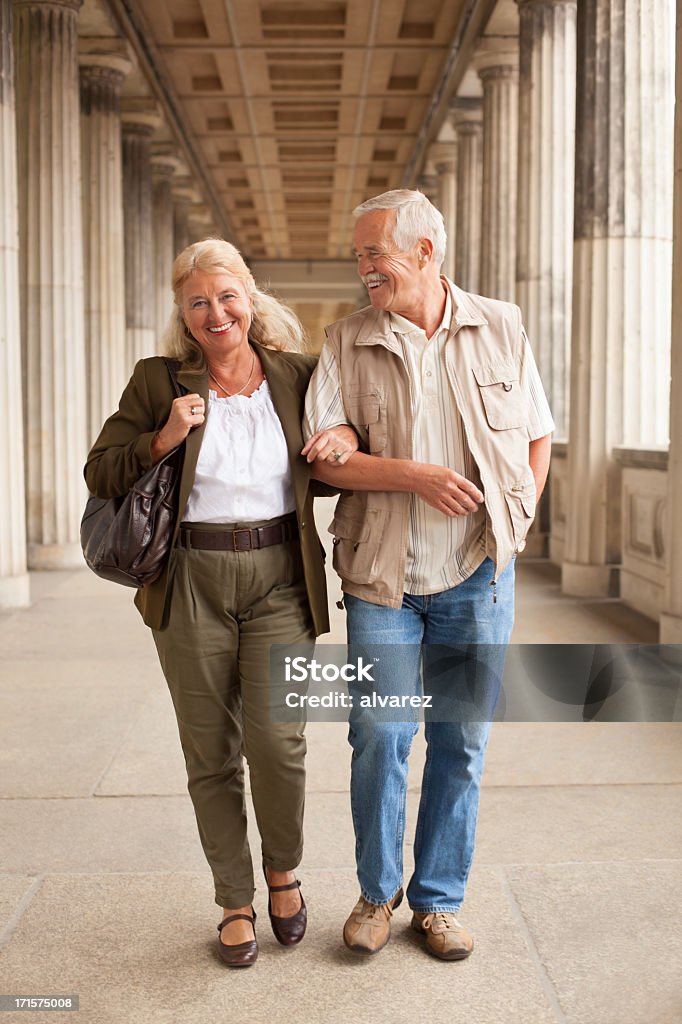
303,189,554,961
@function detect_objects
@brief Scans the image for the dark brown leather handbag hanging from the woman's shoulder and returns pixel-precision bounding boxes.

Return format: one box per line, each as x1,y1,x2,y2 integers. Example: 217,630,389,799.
81,359,185,587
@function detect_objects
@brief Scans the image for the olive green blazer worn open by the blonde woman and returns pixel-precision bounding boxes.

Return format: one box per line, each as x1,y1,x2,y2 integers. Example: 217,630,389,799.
85,343,333,635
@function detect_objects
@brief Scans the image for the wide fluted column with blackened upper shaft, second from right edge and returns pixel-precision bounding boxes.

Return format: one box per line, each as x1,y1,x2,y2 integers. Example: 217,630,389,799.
562,0,673,596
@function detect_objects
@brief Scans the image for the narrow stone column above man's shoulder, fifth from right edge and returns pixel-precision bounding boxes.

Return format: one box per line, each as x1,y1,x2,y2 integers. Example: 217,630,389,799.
451,97,483,292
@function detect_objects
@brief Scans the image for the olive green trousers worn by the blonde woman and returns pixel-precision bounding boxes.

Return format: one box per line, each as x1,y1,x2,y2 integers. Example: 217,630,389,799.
153,520,314,909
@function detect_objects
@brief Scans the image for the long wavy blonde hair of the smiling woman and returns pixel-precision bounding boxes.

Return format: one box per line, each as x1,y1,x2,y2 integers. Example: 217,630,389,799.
162,239,307,373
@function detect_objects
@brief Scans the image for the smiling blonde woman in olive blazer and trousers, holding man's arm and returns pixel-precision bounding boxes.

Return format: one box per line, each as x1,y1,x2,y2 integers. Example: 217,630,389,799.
85,239,357,967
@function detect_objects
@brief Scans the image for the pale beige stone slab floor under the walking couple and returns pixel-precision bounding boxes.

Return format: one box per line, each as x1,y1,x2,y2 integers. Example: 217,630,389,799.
0,499,682,1024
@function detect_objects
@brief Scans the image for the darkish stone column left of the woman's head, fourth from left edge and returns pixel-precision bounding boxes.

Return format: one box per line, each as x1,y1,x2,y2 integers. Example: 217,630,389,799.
122,100,160,374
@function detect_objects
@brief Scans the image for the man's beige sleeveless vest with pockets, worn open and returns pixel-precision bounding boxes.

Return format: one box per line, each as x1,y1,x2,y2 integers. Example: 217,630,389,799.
327,282,536,608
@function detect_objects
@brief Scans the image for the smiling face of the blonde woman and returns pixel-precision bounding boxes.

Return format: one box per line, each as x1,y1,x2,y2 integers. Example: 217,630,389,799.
182,270,253,359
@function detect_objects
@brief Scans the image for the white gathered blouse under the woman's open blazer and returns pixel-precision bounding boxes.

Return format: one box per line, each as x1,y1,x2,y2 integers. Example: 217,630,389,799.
182,380,296,522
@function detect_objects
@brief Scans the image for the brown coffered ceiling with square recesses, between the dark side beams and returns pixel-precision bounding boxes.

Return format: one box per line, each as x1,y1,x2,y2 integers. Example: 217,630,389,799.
115,0,473,260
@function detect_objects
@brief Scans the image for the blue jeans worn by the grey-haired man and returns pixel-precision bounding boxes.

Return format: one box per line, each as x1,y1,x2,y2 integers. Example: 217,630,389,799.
345,558,514,913
